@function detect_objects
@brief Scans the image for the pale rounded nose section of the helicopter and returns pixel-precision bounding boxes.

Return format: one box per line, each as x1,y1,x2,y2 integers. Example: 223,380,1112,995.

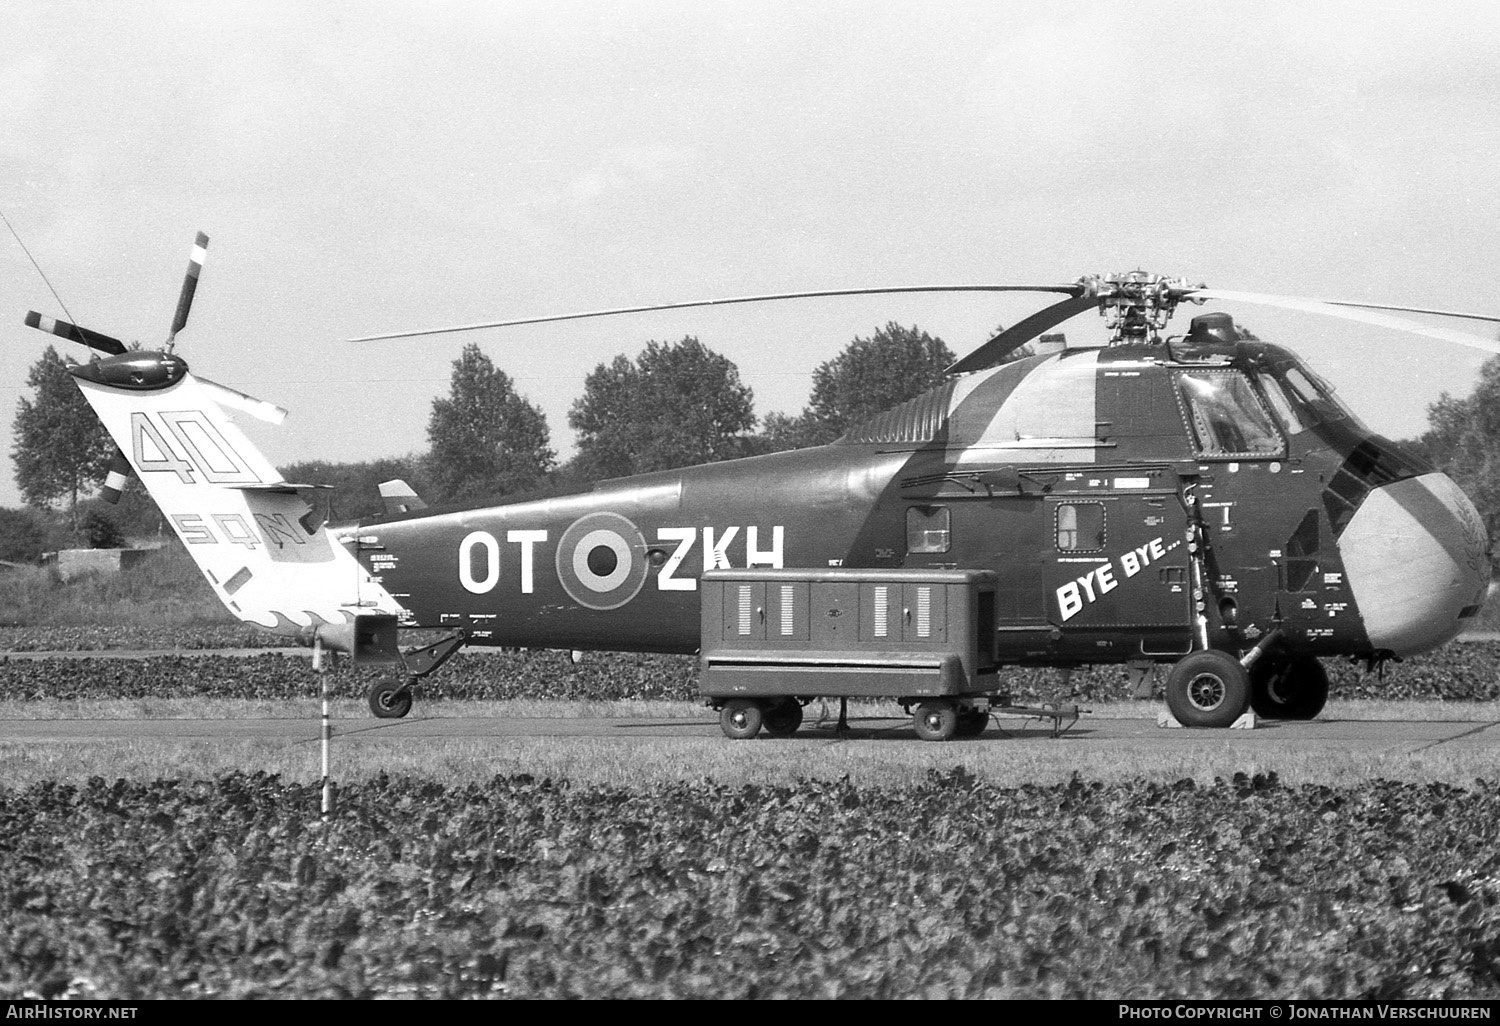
1338,474,1490,656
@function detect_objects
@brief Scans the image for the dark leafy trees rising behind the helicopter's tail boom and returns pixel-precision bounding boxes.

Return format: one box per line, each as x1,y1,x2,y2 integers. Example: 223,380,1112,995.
340,321,954,515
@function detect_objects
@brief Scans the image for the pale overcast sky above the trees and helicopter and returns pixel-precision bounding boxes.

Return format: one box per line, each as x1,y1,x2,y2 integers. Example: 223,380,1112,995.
0,0,1500,506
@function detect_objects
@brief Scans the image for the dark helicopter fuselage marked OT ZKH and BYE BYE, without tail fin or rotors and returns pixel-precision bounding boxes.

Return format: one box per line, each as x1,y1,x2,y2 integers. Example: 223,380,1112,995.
350,336,1490,666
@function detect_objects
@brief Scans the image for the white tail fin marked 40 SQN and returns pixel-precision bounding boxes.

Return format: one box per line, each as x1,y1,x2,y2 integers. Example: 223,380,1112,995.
71,351,404,648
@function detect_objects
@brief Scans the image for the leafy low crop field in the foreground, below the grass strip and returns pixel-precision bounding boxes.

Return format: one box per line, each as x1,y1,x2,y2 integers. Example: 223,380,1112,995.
0,770,1500,999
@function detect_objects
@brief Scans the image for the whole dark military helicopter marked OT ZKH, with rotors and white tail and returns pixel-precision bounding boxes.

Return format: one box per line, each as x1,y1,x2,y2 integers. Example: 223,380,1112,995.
27,236,1500,740
